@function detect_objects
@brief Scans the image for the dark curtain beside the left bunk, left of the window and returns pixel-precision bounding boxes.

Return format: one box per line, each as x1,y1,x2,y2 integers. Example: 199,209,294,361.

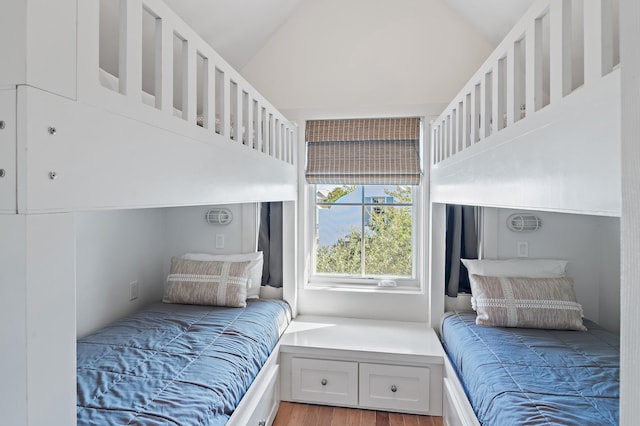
258,202,283,287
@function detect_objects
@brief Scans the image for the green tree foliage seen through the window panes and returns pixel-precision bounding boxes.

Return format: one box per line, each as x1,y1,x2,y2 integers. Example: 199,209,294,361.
316,186,413,276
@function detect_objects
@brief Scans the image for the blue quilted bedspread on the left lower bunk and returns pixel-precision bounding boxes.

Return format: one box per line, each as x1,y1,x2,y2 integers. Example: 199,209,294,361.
77,300,291,425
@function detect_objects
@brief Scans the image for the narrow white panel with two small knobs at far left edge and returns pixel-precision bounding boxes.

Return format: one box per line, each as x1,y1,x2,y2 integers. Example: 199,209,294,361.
0,89,18,214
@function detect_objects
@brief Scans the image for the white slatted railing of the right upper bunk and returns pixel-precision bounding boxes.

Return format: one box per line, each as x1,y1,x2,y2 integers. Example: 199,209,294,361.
431,0,620,166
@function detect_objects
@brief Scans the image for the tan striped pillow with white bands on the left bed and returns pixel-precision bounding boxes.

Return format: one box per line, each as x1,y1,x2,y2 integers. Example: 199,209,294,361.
162,257,250,308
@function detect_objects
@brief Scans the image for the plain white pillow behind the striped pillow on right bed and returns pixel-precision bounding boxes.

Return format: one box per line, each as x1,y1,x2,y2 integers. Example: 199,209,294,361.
460,259,567,278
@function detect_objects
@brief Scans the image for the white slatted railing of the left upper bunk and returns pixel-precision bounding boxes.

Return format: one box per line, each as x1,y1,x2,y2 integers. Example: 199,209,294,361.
77,0,297,165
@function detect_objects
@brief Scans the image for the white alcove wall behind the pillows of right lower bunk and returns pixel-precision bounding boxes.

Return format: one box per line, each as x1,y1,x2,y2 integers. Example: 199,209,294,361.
484,208,620,332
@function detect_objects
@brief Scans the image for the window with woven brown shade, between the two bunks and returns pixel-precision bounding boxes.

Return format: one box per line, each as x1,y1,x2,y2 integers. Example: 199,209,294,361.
305,118,422,288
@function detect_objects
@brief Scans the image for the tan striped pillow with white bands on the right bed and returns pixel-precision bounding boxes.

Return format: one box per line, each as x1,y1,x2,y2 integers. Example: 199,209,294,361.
469,274,586,331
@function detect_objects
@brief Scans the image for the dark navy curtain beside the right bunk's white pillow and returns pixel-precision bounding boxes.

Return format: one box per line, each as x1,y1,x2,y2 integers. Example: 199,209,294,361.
445,205,478,297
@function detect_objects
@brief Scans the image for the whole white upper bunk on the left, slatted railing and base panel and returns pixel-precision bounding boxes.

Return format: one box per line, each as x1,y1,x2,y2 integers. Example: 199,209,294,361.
0,0,297,213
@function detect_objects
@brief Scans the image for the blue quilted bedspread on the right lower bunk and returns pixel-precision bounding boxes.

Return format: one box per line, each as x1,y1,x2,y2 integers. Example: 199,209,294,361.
441,312,620,426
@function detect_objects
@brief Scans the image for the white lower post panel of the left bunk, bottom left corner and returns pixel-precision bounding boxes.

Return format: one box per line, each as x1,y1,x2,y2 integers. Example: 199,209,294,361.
0,213,76,426
